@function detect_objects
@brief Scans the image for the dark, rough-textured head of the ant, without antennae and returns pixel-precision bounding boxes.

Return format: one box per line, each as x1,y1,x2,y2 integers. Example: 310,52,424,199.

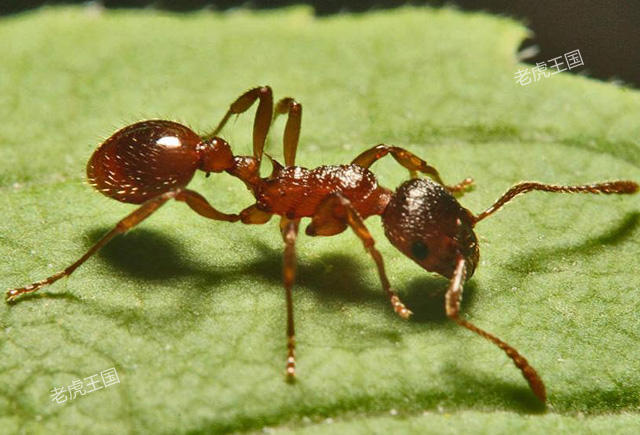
382,179,479,278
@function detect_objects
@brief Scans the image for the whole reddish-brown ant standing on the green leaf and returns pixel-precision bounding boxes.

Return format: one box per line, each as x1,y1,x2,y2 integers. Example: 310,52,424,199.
7,86,639,402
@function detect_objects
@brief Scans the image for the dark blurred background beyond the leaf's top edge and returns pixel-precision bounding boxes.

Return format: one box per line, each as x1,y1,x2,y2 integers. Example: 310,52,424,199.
0,0,640,88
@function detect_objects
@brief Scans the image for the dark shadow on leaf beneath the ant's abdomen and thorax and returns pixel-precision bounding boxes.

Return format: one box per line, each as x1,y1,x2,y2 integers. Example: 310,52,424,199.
88,229,382,305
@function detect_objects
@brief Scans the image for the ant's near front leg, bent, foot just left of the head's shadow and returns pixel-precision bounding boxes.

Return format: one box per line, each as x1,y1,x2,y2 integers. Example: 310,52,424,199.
306,193,413,319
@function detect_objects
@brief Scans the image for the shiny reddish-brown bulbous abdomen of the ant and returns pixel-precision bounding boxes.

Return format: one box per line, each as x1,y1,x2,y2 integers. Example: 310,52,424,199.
87,120,202,204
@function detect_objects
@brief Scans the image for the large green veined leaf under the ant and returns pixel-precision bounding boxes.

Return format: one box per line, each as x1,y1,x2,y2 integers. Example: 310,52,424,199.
0,8,640,433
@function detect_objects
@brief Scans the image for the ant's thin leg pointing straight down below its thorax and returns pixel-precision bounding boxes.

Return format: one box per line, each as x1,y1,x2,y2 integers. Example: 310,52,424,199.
280,217,300,379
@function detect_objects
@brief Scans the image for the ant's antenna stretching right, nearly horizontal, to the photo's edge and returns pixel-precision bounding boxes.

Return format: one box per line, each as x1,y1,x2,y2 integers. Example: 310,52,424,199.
475,181,638,222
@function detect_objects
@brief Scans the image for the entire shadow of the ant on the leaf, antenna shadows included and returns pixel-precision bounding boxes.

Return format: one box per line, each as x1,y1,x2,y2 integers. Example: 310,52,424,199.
25,212,640,413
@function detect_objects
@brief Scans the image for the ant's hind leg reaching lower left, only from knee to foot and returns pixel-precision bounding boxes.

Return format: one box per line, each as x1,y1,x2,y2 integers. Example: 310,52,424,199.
6,190,180,302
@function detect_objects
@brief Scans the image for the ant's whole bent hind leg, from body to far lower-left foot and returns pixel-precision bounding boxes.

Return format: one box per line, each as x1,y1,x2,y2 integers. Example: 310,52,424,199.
6,189,240,302
